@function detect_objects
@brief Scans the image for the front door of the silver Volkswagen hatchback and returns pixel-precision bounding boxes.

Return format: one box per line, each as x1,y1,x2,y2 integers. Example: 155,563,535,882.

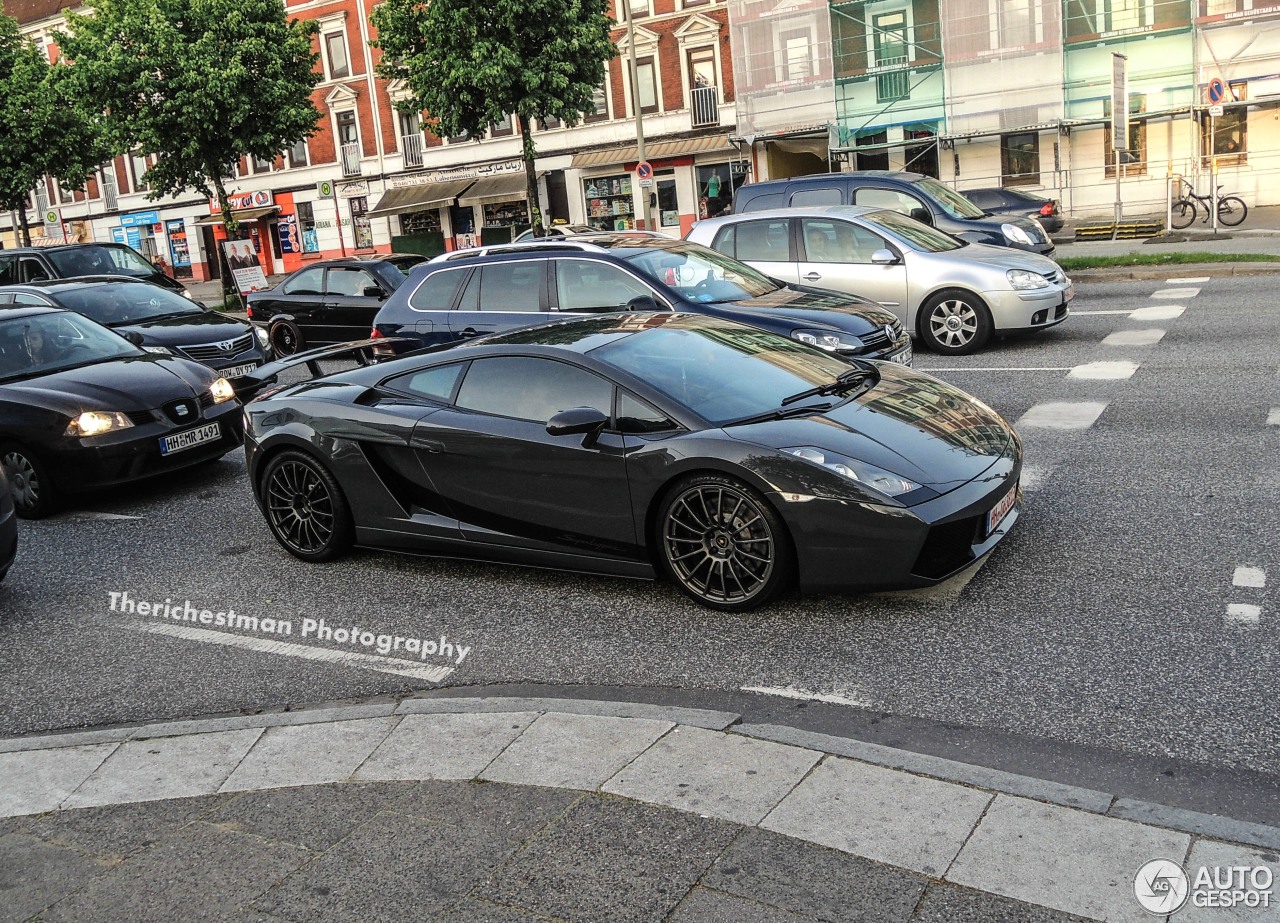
797,218,908,324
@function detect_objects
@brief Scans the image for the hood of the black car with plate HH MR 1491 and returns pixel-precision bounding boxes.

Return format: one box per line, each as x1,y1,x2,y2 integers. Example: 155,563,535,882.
0,355,216,416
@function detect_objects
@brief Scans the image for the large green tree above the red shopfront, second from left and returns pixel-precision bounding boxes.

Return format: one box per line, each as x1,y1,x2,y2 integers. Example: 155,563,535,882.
58,0,320,291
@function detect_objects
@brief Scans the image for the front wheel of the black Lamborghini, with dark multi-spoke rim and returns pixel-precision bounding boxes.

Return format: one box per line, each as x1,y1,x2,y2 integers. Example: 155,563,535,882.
653,474,795,612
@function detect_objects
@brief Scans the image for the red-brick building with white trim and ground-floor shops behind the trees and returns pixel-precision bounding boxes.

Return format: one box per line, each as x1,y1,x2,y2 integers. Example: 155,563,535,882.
0,0,746,279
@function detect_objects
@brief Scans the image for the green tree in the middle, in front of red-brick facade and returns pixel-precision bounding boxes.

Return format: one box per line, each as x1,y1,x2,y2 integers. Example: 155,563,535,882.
371,0,617,234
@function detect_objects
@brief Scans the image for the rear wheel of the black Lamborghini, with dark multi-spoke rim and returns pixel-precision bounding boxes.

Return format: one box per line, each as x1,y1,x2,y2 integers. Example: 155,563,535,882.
259,449,355,563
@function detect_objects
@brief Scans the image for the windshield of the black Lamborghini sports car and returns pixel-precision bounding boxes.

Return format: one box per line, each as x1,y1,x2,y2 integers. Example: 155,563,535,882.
591,320,852,425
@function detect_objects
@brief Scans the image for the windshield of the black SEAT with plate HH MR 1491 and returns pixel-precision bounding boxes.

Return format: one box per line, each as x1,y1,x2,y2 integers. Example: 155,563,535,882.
0,312,143,381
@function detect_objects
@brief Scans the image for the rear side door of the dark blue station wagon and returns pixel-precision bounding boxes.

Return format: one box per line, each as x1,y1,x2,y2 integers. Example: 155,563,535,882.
449,260,554,339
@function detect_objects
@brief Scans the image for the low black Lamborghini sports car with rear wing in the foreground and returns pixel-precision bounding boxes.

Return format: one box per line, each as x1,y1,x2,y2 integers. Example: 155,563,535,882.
244,314,1021,609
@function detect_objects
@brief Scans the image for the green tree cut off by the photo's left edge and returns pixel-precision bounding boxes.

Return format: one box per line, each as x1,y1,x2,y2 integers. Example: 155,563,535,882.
0,14,106,245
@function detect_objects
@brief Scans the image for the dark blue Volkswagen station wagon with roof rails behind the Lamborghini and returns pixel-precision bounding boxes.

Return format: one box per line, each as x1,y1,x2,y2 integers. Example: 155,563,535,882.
372,233,911,365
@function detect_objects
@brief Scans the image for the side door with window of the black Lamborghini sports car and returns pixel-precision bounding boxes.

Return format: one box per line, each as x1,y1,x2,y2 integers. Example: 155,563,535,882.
412,356,639,558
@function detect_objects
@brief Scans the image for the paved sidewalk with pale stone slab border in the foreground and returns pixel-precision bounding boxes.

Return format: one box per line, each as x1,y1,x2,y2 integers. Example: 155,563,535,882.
0,696,1280,923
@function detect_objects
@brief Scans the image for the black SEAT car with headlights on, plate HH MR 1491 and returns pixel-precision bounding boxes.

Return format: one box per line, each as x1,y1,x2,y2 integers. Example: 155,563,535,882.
0,307,242,518
